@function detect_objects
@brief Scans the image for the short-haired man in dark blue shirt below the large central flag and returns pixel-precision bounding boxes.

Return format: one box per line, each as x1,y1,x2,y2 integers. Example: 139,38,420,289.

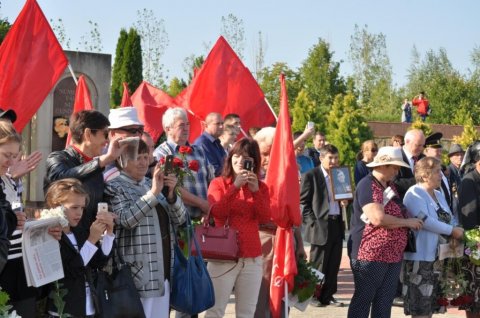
193,113,226,177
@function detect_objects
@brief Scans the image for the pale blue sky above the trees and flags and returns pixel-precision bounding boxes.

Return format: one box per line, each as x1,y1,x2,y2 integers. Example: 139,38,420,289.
0,0,480,86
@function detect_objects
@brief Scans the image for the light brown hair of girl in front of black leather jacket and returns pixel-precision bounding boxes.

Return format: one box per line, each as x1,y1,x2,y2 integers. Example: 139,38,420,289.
45,178,89,209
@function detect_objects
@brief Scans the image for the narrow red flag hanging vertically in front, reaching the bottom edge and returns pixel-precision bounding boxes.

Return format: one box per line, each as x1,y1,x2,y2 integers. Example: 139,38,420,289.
265,74,300,318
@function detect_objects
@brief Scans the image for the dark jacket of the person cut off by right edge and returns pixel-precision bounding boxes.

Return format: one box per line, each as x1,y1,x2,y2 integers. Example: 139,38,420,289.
458,169,480,230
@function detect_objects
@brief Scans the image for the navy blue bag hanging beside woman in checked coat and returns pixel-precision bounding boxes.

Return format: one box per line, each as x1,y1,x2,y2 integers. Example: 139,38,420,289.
170,216,215,315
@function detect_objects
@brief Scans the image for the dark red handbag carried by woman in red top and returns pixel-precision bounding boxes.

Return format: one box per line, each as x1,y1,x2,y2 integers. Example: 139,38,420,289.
192,212,239,262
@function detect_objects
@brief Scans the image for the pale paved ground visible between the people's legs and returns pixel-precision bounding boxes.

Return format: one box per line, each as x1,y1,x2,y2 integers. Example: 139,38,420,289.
171,248,465,318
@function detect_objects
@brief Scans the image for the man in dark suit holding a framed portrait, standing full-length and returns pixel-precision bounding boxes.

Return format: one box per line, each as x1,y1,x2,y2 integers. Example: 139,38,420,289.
300,144,345,306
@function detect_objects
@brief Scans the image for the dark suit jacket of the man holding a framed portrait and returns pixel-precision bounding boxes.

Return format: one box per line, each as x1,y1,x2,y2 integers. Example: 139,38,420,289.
300,167,341,245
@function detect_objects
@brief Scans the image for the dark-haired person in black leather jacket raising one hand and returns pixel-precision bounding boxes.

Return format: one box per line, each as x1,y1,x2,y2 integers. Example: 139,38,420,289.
44,110,126,230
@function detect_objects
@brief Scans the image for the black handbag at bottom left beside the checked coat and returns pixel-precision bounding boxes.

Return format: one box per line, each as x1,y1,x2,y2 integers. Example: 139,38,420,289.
93,253,145,318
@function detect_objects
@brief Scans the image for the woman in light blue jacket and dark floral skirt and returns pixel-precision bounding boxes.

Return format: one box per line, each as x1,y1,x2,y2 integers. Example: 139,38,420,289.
403,157,463,317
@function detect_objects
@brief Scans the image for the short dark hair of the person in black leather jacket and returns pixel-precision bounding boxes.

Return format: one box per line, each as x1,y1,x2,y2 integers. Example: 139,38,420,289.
69,110,110,144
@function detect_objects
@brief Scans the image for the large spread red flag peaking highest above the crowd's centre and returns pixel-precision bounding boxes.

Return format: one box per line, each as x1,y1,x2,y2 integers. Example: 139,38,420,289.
175,37,275,141
